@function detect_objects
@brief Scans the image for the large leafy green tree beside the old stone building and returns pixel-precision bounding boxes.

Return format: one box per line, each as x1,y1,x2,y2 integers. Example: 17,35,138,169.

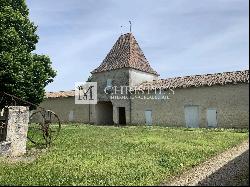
0,0,56,109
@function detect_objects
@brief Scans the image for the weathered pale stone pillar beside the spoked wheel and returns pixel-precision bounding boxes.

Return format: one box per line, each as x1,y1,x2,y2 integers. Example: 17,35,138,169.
6,106,29,156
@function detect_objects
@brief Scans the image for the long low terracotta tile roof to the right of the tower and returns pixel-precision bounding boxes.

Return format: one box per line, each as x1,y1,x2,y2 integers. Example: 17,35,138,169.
137,70,249,90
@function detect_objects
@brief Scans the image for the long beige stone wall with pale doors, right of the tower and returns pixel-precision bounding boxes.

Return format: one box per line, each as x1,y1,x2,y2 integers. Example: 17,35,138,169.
132,84,249,128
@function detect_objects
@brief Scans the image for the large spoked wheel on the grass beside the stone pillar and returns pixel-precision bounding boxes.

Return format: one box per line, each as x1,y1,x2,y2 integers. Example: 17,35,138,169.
28,110,61,145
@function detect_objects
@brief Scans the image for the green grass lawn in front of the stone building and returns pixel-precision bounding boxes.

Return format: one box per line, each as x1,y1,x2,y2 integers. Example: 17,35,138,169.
0,125,248,185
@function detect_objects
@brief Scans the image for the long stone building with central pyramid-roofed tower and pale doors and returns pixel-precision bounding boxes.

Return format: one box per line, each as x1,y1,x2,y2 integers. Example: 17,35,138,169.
41,33,249,128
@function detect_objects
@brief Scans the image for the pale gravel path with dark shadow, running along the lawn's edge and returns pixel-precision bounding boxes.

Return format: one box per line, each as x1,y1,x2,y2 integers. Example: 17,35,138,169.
164,140,249,186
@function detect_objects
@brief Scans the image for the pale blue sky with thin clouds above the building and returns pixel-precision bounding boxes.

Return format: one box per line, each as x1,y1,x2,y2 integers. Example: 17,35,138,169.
26,0,249,91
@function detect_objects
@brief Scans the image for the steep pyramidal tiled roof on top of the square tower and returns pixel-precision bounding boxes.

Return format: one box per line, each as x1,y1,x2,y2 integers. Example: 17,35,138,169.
91,33,159,75
